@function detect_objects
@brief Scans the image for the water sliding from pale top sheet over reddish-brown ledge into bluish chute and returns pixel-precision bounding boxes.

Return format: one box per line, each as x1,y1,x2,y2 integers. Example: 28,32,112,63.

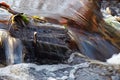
0,0,119,61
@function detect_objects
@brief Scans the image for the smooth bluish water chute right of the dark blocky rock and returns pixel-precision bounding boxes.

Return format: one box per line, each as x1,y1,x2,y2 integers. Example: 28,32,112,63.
68,30,119,61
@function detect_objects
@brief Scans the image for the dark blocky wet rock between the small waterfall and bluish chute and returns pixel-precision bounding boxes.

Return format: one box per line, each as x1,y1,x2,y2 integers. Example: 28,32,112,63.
10,24,74,64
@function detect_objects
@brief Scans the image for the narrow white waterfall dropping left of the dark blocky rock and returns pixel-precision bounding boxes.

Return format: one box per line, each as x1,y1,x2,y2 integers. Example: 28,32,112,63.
0,29,22,64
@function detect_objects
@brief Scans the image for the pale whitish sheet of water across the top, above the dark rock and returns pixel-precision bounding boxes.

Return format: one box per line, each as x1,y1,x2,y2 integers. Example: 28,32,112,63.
4,0,97,22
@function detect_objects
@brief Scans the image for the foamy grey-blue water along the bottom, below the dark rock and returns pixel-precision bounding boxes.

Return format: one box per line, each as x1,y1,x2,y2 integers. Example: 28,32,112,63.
0,53,120,80
